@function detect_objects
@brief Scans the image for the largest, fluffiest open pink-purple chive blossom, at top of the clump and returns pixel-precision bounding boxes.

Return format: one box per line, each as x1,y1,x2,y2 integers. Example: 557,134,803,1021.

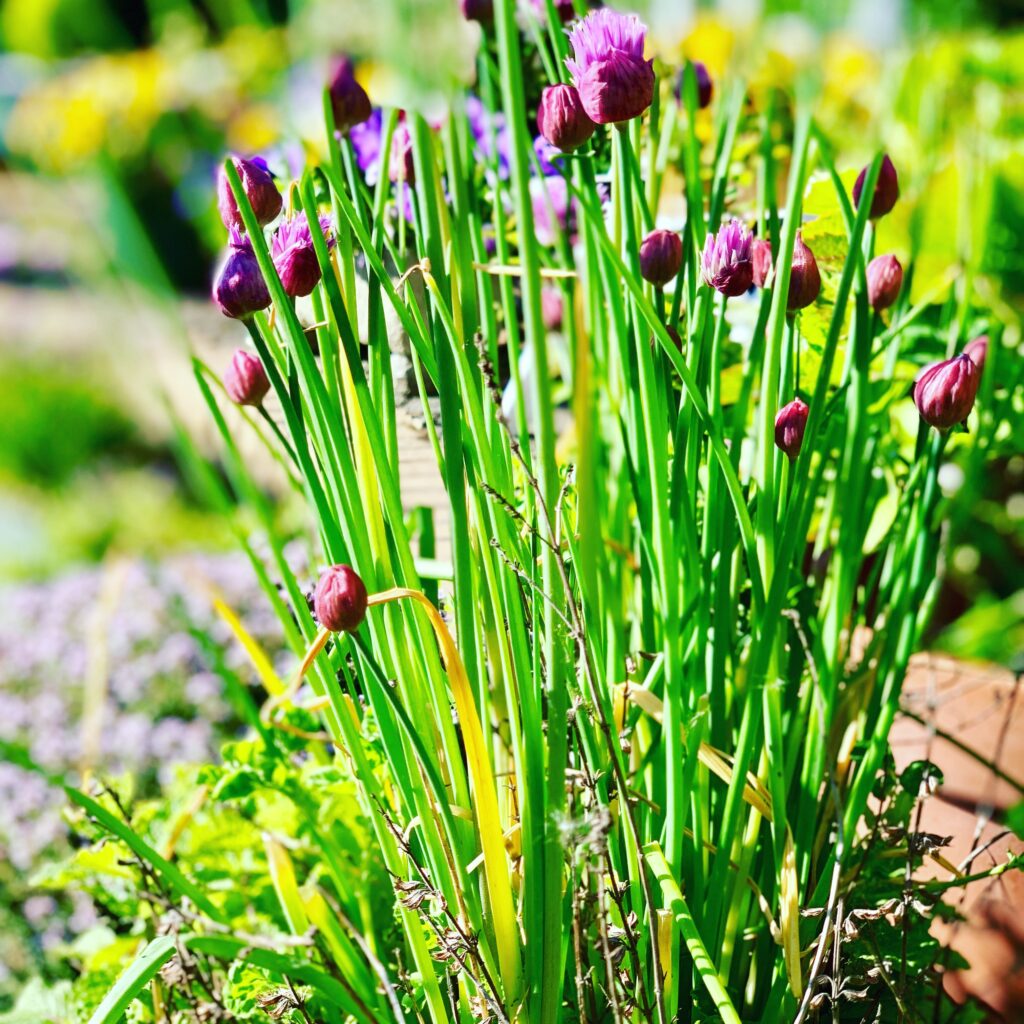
565,7,654,125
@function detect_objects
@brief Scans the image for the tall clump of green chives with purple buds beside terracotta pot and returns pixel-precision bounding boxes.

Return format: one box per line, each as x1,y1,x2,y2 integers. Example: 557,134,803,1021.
176,0,998,1024
